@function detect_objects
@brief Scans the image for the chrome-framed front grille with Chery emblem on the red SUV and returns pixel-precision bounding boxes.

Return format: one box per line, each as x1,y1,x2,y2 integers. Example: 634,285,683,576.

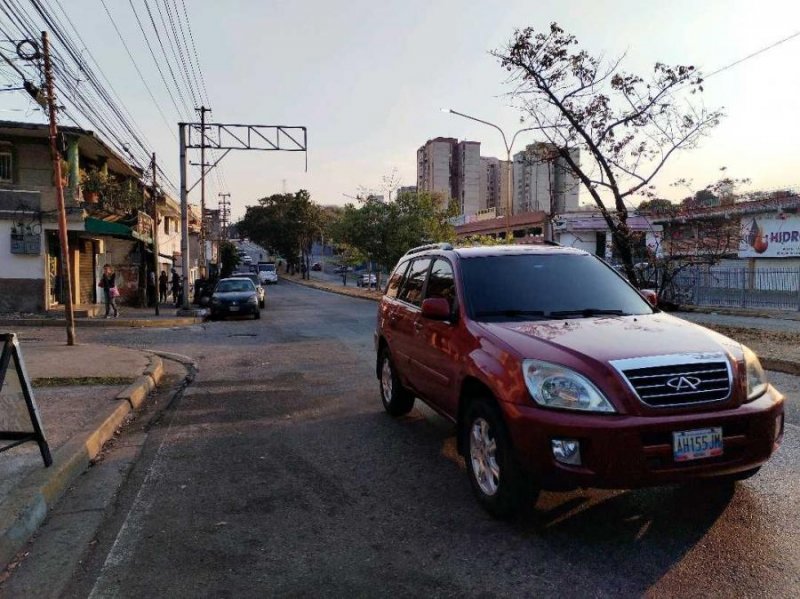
612,354,731,408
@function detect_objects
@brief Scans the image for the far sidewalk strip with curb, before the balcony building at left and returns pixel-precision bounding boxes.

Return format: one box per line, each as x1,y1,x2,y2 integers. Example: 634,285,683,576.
0,304,205,328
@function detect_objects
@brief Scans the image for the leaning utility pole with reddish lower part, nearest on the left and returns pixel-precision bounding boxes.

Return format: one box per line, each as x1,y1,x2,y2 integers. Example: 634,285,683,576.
42,31,75,345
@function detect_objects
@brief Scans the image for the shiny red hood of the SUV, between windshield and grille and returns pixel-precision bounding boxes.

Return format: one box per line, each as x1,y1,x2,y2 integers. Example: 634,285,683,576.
480,313,742,362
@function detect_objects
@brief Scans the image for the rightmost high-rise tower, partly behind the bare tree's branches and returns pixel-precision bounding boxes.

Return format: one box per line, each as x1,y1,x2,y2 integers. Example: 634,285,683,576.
513,142,580,214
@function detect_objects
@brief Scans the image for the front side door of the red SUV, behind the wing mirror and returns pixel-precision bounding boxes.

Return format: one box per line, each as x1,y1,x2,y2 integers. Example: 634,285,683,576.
411,258,460,414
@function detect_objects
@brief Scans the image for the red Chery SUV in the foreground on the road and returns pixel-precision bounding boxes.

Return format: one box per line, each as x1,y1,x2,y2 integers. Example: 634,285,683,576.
375,244,784,516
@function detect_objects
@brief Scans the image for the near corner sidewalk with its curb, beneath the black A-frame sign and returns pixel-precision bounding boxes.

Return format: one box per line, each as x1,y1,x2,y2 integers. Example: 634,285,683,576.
0,342,169,571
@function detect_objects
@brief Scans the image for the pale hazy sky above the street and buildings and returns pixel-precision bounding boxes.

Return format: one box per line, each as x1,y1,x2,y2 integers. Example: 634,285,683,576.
0,0,800,220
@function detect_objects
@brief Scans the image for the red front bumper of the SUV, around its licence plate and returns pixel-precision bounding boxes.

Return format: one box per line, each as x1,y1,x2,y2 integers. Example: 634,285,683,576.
503,386,784,489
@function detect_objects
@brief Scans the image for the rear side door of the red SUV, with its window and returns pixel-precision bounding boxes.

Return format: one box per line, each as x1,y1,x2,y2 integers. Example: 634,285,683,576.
390,258,431,391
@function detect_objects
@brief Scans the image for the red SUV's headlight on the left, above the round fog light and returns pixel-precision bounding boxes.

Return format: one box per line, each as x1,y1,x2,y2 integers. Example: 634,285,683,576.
522,360,616,412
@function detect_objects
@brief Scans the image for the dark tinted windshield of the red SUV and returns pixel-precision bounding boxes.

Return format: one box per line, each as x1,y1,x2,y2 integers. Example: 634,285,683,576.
461,254,653,320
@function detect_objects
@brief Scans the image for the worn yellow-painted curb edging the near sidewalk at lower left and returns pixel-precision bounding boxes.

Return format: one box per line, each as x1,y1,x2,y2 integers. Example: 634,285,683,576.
0,355,164,570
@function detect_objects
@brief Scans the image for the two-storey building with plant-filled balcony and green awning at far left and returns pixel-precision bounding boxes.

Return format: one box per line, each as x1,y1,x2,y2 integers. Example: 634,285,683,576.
0,121,153,312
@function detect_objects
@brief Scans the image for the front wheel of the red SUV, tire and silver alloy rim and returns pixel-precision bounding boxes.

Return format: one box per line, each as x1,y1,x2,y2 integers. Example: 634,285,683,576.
459,399,538,519
